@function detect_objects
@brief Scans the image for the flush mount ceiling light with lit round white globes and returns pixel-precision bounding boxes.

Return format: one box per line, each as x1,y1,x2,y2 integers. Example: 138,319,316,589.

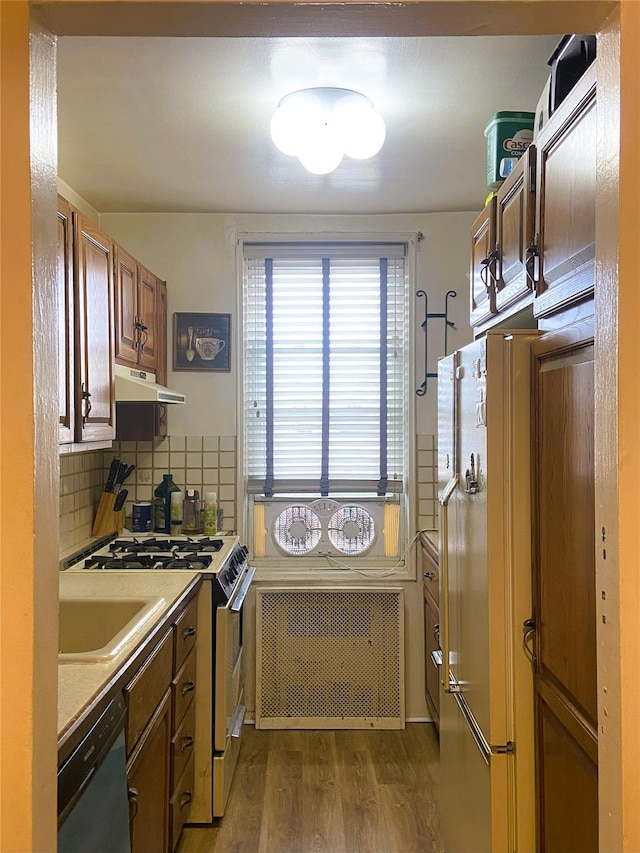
271,87,386,175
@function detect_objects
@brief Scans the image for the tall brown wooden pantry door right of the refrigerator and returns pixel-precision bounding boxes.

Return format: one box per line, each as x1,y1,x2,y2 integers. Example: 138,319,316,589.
533,322,598,853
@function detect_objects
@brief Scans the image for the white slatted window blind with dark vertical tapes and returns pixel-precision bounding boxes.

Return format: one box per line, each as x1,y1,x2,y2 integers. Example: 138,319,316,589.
244,243,407,496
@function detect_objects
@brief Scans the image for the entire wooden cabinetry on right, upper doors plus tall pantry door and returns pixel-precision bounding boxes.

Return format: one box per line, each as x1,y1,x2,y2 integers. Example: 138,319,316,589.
462,63,598,853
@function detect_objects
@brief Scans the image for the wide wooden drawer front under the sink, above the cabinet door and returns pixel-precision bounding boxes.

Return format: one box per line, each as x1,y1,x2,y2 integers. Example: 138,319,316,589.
123,629,173,755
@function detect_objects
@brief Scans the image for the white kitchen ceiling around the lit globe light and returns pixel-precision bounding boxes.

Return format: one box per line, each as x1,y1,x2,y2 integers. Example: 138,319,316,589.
58,35,560,214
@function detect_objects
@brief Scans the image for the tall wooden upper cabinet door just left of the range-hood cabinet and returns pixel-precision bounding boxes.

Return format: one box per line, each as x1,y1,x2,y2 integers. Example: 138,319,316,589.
73,211,115,442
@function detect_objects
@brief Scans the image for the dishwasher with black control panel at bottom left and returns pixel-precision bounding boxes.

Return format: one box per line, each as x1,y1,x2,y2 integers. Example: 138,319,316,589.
58,693,131,853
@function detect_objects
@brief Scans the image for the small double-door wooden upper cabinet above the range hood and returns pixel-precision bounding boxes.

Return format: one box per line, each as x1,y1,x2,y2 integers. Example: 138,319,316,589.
115,246,164,373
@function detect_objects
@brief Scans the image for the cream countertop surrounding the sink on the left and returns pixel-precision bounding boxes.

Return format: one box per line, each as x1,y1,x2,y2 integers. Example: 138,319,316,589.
58,570,200,740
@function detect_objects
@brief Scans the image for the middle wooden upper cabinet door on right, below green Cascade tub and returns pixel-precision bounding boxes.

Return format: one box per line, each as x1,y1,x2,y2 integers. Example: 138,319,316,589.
494,145,536,315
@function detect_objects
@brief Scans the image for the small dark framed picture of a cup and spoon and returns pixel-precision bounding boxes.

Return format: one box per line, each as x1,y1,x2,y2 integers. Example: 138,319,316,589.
173,313,231,370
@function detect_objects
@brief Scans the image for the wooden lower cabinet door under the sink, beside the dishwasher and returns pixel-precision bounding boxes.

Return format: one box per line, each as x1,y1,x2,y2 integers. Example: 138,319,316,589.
127,690,171,853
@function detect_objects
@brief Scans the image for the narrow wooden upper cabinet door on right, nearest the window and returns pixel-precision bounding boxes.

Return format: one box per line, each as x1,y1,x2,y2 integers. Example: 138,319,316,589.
470,196,497,326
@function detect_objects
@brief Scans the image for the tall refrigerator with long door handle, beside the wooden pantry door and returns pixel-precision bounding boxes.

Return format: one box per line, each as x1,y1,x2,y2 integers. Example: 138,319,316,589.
438,331,537,853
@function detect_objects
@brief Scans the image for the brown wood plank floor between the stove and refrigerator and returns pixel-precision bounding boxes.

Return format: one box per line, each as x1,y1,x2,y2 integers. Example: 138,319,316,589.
178,723,442,853
